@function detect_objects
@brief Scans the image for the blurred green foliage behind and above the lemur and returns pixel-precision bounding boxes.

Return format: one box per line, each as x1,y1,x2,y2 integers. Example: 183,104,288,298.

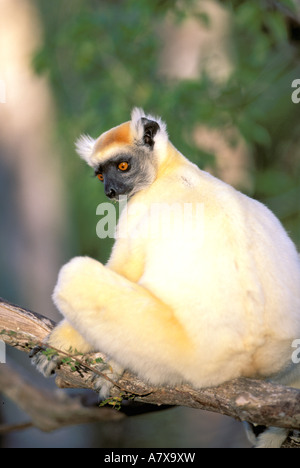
34,0,300,260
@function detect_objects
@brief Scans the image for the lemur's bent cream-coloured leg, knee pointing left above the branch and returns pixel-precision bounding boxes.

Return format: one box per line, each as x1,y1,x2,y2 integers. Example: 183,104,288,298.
53,257,191,383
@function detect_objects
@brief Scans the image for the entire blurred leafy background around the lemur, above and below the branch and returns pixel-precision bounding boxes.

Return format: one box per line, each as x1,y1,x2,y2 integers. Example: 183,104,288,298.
0,0,300,447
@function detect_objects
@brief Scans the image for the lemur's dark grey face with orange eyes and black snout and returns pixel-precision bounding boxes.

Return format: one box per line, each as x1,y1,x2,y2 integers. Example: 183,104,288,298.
95,149,155,200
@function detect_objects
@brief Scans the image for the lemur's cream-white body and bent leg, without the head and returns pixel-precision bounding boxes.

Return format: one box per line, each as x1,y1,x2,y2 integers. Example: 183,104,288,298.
54,163,300,387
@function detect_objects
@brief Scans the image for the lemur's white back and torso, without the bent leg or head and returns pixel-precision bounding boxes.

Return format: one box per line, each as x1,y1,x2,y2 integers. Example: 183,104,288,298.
133,157,300,384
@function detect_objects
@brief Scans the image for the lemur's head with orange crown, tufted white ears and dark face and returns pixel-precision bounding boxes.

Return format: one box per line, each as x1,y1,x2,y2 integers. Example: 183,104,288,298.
76,108,168,199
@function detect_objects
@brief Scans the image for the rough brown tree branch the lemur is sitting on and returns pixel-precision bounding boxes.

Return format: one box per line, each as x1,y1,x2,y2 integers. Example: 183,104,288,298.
0,299,300,436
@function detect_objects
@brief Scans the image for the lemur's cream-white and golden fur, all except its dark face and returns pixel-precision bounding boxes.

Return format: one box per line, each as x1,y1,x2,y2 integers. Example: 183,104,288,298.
41,109,300,446
